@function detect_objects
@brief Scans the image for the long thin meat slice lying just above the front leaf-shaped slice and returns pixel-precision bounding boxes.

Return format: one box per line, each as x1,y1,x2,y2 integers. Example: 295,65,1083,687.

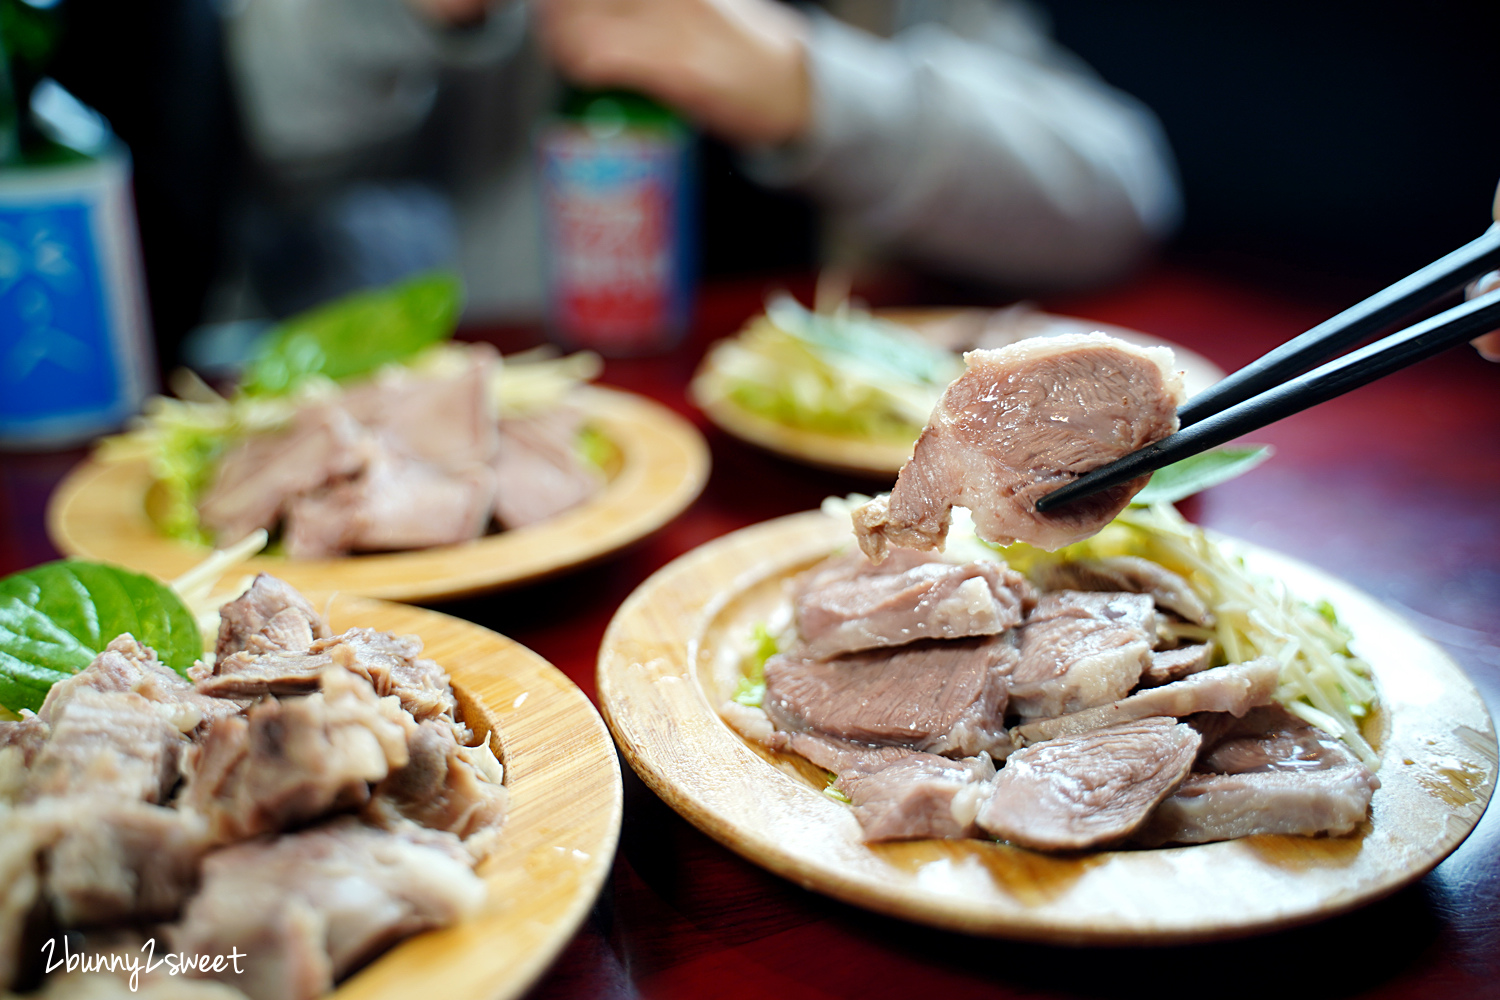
1011,657,1281,747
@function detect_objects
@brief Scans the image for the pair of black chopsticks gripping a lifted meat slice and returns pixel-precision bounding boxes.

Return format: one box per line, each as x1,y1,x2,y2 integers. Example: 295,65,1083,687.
1037,274,1500,511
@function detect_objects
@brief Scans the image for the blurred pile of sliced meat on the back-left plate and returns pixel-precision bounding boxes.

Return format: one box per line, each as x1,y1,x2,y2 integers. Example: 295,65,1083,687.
198,343,603,558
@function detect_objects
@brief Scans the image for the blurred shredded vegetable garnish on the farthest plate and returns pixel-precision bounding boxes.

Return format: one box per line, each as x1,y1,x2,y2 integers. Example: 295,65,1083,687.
693,297,963,441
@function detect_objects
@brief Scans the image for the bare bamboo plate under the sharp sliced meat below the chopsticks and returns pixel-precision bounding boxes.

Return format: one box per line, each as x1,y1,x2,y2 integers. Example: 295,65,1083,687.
599,511,1497,945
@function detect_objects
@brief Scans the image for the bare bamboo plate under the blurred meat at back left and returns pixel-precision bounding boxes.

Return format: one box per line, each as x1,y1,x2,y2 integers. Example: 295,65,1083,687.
47,385,708,601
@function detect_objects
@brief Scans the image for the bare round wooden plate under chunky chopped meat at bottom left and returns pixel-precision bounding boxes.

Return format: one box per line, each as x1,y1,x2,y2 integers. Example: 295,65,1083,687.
309,594,624,1000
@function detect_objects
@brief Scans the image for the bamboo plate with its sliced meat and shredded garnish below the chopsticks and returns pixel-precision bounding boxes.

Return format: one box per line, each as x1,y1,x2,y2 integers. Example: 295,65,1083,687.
599,508,1496,945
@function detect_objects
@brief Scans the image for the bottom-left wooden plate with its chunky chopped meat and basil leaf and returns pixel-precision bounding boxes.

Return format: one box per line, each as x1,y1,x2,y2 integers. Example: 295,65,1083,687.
0,562,623,1000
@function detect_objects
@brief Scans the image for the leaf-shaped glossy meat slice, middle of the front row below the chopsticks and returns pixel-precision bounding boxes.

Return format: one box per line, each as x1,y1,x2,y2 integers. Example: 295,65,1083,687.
977,717,1202,850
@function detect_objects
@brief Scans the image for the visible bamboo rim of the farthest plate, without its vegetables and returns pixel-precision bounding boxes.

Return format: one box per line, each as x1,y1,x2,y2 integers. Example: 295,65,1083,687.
695,309,1224,481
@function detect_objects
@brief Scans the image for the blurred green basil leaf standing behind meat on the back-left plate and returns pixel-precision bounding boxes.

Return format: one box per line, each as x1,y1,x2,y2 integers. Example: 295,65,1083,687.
240,271,464,396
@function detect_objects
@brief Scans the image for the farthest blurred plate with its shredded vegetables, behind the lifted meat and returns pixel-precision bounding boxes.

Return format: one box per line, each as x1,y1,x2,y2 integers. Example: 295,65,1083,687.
692,297,1224,480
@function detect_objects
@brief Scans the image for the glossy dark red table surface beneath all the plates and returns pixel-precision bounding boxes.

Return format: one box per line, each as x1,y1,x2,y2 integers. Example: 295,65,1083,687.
0,268,1500,1000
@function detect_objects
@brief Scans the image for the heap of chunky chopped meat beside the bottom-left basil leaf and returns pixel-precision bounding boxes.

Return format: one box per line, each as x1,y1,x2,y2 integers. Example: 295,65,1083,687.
0,574,509,1000
